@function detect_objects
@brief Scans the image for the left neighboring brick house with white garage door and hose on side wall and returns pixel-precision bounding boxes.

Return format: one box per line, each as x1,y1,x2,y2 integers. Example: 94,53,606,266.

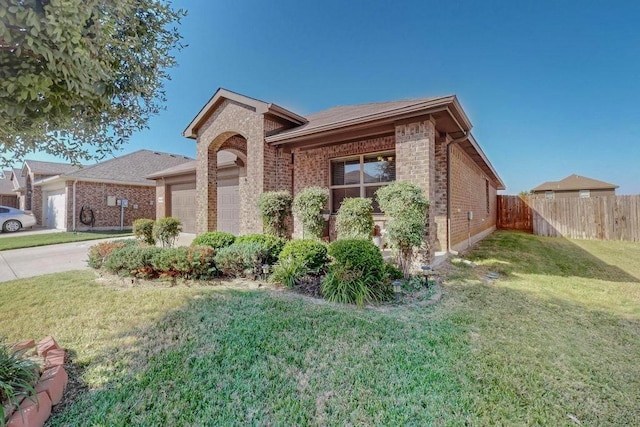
33,150,193,230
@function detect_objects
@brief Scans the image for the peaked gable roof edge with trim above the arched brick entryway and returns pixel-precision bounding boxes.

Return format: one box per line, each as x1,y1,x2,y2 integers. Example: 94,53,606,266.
182,88,306,139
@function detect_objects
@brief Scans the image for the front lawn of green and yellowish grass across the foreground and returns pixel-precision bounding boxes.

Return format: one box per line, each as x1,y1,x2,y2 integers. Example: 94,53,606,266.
0,232,640,425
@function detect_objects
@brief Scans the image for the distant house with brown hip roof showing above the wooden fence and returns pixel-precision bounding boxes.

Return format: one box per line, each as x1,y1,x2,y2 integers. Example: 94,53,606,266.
531,174,618,199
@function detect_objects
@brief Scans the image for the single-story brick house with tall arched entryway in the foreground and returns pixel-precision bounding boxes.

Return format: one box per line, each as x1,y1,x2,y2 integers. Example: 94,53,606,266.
155,89,505,256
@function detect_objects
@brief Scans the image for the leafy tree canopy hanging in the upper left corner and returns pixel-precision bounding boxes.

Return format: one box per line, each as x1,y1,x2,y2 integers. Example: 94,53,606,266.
0,0,186,163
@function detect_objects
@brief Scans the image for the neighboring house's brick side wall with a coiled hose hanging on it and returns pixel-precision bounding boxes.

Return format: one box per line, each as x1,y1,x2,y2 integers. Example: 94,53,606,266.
67,181,156,230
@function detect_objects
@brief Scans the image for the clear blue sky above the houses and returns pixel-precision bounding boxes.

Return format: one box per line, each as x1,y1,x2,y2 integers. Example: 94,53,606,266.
25,0,640,194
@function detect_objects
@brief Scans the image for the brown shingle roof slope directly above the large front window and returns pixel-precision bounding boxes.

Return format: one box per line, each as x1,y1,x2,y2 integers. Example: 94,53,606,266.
274,95,454,138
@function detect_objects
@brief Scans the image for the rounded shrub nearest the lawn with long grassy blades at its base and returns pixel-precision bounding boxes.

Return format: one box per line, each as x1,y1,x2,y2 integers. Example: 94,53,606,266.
322,239,393,306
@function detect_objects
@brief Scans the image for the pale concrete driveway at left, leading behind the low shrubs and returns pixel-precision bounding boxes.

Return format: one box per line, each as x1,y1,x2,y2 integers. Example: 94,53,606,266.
0,233,195,282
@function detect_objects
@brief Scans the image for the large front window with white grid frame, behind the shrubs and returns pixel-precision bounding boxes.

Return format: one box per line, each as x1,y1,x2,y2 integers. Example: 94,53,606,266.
331,151,396,213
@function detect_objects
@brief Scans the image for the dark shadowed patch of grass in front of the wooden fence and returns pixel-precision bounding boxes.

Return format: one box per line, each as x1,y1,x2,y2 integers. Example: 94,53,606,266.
469,231,640,283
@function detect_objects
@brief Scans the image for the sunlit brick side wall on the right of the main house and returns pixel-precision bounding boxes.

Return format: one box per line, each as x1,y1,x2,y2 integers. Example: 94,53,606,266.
450,145,497,250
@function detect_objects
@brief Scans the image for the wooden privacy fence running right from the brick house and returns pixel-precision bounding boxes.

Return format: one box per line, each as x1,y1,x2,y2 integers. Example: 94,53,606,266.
498,195,640,242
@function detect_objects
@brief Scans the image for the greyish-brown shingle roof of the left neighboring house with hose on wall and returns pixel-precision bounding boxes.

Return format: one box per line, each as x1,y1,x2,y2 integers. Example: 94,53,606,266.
64,150,193,185
